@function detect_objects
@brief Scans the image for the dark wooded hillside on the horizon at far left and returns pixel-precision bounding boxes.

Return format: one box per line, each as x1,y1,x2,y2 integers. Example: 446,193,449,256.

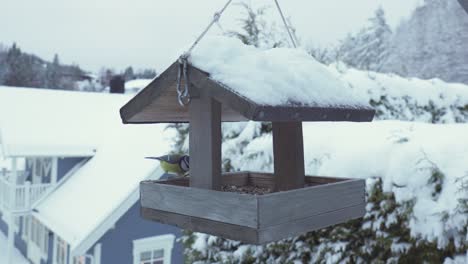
0,44,90,90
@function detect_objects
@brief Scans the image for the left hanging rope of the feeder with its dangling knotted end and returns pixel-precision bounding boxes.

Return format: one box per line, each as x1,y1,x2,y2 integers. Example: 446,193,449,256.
177,0,232,106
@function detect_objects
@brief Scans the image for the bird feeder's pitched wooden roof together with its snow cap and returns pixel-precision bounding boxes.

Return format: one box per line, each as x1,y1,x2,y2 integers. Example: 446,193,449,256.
121,37,374,123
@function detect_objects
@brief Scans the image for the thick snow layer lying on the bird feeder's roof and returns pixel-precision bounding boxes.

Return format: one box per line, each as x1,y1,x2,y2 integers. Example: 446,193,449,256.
189,37,369,107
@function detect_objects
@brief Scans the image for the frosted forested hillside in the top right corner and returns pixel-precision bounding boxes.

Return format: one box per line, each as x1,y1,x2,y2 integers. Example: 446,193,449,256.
382,0,468,83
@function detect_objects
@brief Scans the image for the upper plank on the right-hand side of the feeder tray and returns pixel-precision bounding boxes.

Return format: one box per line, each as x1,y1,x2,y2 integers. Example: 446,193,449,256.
258,180,365,228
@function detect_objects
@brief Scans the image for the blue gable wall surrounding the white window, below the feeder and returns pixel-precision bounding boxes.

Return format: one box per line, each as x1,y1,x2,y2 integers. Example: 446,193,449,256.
88,201,184,264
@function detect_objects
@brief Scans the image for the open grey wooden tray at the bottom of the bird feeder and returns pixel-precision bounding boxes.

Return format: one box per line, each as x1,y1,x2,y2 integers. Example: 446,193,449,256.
141,172,365,244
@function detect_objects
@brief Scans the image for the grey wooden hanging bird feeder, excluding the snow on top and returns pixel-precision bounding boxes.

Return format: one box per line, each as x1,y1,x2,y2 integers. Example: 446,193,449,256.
120,62,374,244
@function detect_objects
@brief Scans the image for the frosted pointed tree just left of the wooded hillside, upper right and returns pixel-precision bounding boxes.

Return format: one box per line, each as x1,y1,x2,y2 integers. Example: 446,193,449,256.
337,8,392,71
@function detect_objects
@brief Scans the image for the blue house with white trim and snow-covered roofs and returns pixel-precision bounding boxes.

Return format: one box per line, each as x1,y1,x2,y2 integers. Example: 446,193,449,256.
0,87,182,264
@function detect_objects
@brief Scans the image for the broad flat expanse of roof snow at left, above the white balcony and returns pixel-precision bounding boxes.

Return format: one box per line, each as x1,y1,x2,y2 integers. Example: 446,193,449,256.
0,86,130,156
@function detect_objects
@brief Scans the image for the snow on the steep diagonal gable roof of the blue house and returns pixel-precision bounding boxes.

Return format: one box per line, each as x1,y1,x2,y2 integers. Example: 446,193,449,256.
35,125,170,250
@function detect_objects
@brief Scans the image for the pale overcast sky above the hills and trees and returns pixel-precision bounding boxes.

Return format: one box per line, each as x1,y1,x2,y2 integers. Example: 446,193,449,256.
0,0,422,72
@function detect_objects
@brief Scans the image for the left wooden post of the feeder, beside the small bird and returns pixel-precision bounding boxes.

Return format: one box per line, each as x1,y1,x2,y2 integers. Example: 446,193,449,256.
189,95,221,190
